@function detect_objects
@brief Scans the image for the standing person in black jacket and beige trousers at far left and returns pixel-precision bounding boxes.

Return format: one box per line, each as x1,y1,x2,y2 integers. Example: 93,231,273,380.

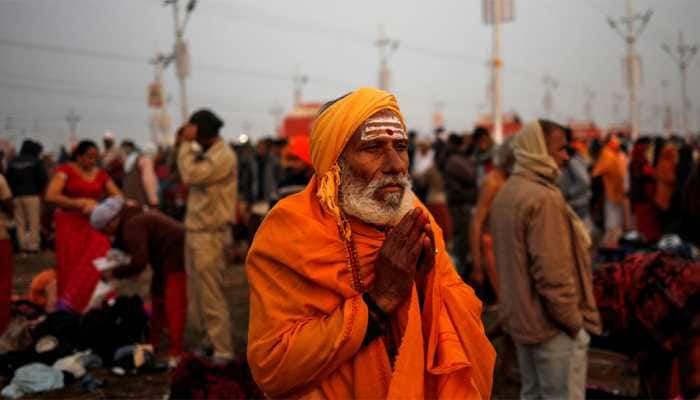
7,140,48,252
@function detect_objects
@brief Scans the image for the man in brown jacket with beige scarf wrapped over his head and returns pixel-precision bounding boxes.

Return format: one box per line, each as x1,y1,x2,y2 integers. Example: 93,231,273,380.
490,120,601,399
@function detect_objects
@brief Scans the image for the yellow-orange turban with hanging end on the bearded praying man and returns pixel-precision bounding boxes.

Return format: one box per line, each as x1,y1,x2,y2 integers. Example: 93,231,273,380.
311,87,406,239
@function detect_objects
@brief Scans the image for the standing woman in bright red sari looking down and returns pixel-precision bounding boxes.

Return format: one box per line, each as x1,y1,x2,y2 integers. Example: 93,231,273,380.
46,140,121,312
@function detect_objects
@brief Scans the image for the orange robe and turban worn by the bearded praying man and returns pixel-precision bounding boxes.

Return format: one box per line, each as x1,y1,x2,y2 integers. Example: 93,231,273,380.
246,88,495,399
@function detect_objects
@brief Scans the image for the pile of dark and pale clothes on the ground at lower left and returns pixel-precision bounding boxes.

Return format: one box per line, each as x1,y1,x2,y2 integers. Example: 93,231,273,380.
0,296,167,399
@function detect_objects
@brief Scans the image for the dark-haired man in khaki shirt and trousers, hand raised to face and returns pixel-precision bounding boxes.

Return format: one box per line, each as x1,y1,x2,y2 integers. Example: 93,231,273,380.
178,110,237,363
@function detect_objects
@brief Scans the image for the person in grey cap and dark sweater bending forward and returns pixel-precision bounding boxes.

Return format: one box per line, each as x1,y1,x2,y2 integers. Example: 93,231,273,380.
90,197,187,365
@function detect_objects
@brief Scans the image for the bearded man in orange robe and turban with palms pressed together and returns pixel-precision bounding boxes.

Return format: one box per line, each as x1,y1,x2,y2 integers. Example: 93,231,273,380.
246,88,495,399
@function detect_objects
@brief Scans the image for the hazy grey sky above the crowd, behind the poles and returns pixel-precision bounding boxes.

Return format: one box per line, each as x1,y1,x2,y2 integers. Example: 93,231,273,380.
0,0,700,150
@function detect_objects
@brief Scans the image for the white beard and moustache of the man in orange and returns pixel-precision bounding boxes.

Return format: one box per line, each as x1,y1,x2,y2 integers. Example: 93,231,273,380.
339,163,415,226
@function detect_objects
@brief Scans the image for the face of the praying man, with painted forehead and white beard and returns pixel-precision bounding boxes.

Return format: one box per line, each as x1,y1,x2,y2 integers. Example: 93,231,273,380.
340,111,412,225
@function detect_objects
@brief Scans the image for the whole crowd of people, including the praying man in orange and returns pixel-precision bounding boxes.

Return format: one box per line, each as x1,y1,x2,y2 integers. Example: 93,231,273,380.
0,88,700,398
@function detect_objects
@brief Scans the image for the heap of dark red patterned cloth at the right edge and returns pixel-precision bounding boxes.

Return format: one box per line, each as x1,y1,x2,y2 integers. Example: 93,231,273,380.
593,236,700,398
